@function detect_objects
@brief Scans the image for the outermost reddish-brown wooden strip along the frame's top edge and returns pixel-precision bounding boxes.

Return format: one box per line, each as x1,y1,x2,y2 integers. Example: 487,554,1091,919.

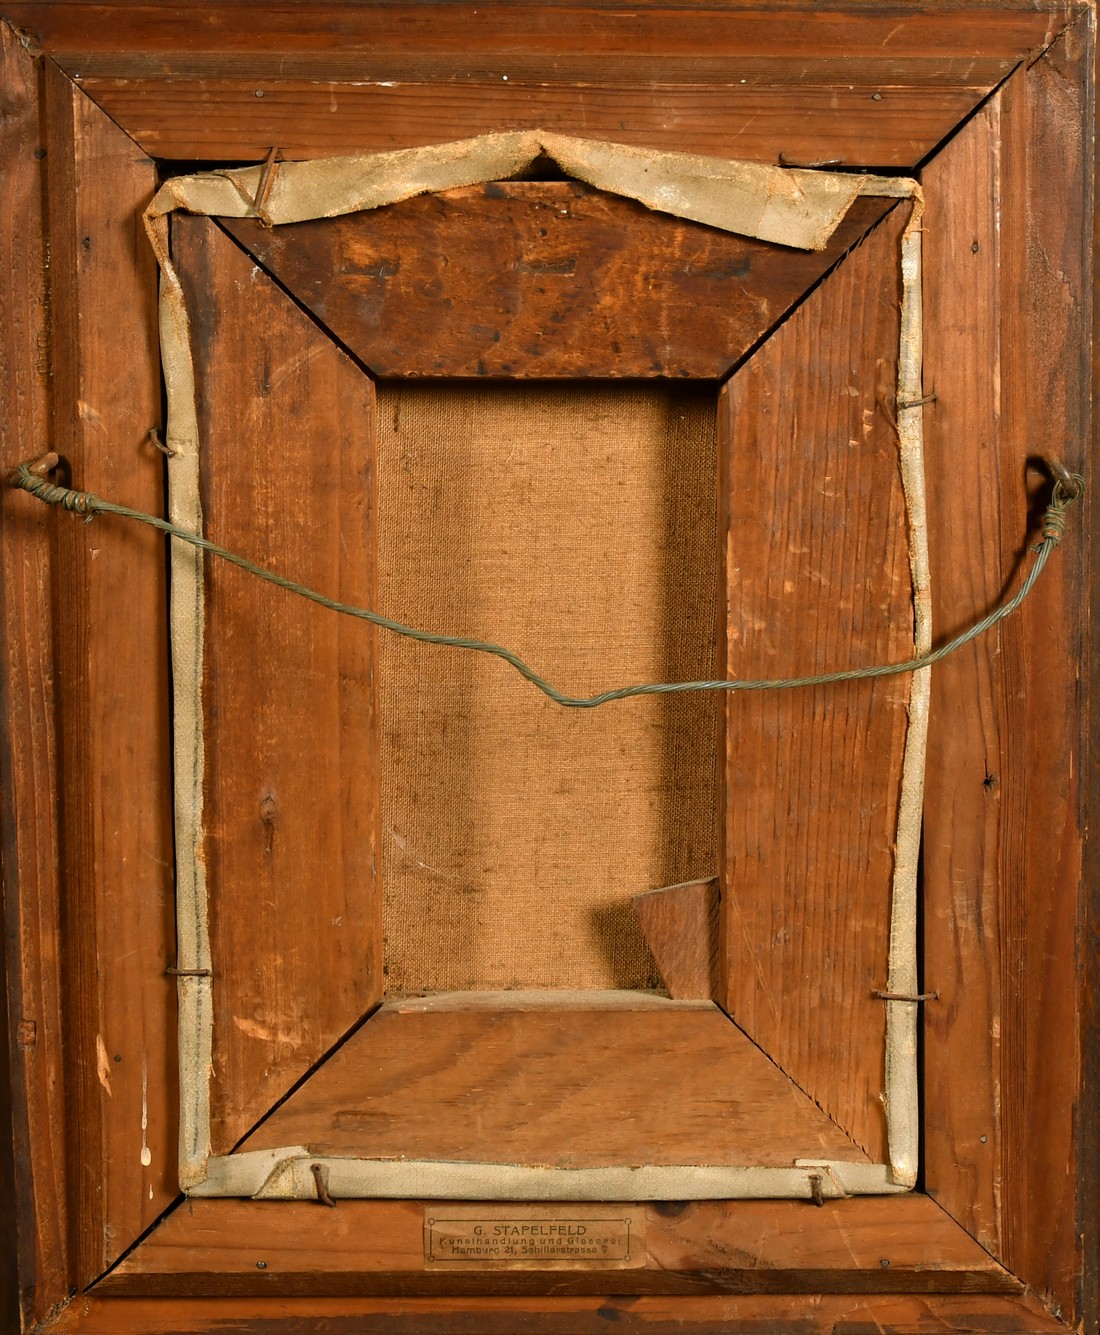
5,0,1087,70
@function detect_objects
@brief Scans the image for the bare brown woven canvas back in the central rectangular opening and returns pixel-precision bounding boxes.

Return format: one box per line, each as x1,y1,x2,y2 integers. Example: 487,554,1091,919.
378,383,718,993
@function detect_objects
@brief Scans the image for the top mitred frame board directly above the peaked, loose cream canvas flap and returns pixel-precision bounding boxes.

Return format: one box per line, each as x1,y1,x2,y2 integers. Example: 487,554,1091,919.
68,75,989,170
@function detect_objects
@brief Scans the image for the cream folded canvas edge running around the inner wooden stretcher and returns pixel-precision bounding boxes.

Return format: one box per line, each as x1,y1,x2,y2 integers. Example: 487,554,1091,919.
146,131,930,1200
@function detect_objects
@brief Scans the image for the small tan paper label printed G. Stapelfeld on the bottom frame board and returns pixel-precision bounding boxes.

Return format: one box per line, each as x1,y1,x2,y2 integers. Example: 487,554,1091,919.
425,1206,646,1270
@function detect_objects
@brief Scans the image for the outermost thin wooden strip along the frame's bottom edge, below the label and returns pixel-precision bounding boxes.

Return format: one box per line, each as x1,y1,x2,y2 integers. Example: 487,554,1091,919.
45,1294,1067,1335
